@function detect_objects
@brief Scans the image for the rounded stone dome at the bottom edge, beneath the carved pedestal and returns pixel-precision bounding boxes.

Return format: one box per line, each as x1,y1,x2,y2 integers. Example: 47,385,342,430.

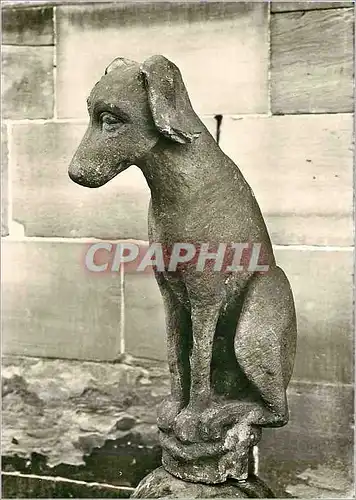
131,467,275,498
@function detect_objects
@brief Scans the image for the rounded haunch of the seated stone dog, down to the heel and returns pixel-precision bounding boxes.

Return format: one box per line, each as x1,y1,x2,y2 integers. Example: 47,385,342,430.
235,267,297,426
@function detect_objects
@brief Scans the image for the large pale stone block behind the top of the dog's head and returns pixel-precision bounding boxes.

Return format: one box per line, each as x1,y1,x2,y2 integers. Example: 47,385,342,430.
57,2,268,117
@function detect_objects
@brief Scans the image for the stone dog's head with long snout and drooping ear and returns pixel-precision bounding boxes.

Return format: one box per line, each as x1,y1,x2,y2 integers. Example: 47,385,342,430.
69,56,199,187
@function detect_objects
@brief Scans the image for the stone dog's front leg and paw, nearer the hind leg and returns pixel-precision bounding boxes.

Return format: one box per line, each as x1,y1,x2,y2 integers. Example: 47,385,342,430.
174,302,221,443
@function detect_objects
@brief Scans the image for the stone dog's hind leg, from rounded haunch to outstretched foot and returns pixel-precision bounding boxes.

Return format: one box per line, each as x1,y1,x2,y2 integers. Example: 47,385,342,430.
201,267,297,439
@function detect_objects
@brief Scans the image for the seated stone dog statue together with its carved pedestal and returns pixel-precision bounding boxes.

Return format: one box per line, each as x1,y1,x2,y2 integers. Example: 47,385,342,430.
69,56,296,484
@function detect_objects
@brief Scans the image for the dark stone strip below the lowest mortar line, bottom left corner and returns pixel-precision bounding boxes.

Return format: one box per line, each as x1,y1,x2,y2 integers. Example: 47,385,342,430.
1,473,132,498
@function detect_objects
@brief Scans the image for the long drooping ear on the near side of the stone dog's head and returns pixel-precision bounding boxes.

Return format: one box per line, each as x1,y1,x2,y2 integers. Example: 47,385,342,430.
140,56,200,144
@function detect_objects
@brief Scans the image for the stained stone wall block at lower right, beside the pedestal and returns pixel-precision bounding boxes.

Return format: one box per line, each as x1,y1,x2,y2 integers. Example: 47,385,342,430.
259,382,354,498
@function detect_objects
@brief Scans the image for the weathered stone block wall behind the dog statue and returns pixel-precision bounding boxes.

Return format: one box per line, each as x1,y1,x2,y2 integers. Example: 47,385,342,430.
1,1,354,498
